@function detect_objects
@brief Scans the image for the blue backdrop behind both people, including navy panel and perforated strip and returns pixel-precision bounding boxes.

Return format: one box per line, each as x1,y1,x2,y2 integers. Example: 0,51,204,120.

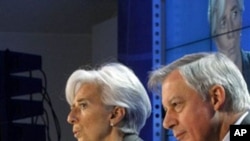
118,0,250,141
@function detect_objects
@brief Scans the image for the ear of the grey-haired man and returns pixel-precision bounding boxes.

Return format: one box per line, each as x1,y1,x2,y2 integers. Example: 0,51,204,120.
209,85,226,111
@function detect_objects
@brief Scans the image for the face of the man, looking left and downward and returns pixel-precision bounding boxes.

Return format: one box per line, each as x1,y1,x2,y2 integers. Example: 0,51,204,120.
162,70,218,141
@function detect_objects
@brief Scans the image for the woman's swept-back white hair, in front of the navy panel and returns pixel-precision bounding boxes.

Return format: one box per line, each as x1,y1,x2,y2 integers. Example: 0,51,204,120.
65,63,152,134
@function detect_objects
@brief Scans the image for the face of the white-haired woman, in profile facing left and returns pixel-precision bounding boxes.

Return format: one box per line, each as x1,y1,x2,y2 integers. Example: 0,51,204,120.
67,84,111,141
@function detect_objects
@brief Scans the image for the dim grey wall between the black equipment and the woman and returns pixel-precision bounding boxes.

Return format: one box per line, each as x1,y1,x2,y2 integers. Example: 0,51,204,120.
0,18,117,141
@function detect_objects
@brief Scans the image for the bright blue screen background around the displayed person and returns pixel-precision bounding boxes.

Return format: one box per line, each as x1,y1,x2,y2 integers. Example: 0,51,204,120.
162,0,250,63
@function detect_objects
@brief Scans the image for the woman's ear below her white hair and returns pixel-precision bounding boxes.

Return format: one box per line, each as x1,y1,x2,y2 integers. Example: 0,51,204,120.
110,106,126,126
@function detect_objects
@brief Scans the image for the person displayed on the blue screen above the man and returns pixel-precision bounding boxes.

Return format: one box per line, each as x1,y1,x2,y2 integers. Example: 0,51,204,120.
208,0,250,90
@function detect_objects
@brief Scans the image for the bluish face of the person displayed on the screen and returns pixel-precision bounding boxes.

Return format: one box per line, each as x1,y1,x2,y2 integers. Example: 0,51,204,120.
215,0,242,53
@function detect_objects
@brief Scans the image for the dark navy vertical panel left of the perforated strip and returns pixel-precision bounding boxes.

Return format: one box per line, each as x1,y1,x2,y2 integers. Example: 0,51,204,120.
118,0,153,141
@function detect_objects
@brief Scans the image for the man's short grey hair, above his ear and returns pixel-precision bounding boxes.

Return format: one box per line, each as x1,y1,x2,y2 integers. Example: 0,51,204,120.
148,53,250,112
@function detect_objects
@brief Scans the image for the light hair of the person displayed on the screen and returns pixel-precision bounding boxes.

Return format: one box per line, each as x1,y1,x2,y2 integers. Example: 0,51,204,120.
208,0,244,36
